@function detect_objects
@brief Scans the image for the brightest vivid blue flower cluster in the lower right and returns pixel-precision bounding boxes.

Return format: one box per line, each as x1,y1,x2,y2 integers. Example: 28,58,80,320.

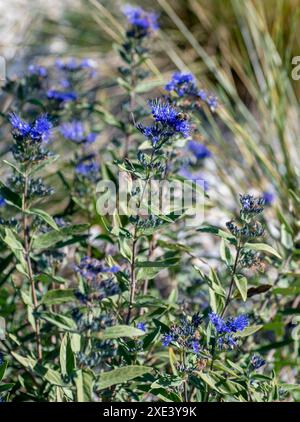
209,312,249,348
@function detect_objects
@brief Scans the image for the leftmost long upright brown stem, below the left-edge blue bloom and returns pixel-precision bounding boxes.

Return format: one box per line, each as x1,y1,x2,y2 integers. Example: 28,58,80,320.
22,172,43,360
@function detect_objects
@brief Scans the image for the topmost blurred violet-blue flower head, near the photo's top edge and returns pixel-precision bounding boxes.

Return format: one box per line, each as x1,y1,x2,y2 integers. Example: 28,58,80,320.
122,4,159,37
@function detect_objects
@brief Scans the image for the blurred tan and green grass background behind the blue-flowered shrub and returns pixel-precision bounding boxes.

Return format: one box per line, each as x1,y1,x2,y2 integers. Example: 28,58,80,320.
0,0,300,239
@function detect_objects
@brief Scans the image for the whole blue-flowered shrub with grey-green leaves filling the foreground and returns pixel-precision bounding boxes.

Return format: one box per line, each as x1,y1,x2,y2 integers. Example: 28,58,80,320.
0,5,300,402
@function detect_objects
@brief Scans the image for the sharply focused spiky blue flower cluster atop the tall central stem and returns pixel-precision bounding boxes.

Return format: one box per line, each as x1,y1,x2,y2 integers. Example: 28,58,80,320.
137,99,190,146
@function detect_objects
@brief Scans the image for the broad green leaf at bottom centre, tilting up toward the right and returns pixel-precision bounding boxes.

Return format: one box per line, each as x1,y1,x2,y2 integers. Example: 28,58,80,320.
97,365,153,390
